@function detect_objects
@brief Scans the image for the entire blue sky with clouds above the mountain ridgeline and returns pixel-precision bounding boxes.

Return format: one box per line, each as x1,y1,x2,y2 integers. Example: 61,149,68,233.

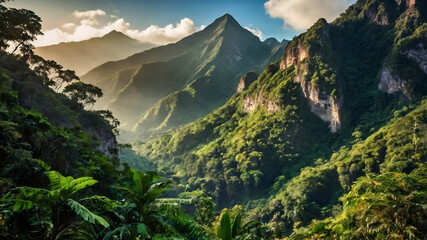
5,0,355,46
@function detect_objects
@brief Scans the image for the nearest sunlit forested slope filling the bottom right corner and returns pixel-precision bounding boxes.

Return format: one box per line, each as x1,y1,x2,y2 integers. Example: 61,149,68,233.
286,100,427,239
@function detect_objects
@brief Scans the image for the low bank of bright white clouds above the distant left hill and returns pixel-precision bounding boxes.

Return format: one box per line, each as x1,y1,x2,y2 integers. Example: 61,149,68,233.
33,9,204,47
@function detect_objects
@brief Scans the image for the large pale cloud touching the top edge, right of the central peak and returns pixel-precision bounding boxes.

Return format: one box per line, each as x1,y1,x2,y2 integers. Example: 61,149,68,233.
264,0,354,30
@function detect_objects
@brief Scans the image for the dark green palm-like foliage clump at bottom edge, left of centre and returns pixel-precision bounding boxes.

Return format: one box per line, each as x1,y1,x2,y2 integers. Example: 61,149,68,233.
104,169,203,240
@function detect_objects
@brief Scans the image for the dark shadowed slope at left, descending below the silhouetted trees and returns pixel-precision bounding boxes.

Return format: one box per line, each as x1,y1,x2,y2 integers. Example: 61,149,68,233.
0,52,117,157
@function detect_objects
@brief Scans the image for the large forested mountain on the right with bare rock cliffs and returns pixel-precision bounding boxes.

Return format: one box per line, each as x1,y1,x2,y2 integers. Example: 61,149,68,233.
134,0,427,238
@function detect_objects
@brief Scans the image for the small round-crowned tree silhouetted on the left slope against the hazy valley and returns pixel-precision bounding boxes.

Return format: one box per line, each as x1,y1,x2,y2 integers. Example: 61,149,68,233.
63,82,103,106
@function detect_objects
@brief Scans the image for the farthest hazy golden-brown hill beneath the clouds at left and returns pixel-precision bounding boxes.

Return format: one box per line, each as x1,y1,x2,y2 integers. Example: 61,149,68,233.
34,31,154,75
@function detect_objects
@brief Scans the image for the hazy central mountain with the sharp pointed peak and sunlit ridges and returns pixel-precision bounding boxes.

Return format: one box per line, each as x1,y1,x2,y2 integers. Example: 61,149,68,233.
82,14,286,139
